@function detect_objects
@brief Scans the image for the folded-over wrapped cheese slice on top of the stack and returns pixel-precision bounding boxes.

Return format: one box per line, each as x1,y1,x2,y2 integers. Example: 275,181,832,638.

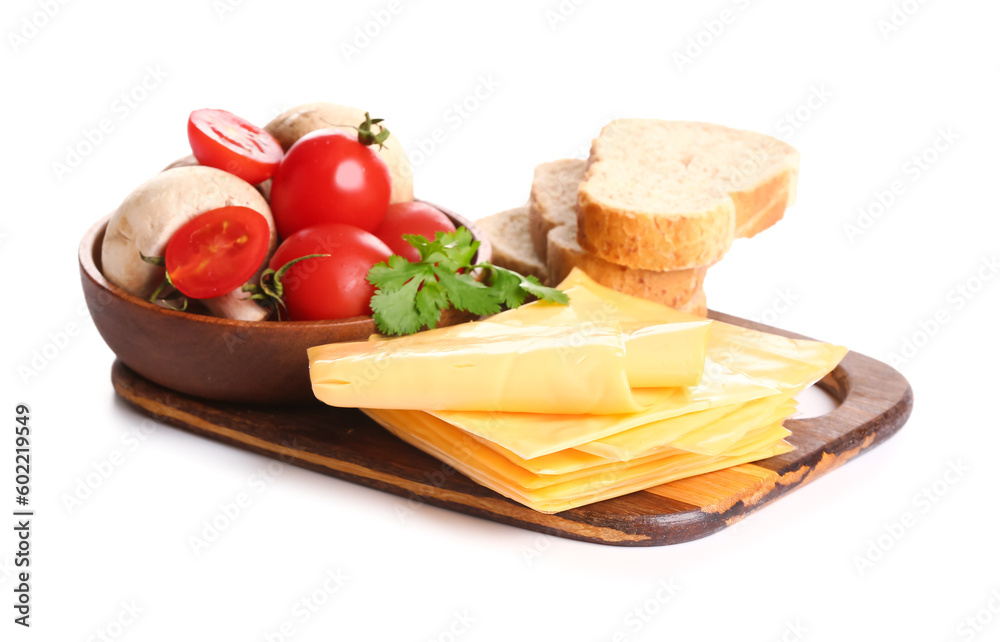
309,310,711,414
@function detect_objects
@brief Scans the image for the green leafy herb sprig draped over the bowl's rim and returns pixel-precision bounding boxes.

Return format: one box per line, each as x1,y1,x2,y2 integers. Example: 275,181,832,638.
368,227,569,335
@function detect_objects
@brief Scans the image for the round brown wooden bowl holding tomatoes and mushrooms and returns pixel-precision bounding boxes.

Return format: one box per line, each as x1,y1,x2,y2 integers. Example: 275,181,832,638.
80,206,491,403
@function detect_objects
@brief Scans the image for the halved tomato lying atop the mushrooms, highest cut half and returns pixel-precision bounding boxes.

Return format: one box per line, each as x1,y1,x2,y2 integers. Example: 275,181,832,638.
188,109,284,185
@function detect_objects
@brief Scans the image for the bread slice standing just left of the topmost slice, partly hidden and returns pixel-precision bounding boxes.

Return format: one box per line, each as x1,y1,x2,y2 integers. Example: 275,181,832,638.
528,158,587,260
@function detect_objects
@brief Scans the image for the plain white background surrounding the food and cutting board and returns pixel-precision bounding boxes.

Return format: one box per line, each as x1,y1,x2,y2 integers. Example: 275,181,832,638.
0,0,1000,642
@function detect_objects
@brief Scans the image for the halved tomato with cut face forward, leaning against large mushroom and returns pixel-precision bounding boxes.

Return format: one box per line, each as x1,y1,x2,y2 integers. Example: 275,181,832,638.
164,205,271,299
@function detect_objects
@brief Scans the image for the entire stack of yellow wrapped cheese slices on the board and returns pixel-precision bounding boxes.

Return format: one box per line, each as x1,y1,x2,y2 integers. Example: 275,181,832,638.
309,270,846,513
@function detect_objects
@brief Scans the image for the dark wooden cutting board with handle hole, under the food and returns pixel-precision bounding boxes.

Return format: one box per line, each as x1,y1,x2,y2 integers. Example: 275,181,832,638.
111,312,913,546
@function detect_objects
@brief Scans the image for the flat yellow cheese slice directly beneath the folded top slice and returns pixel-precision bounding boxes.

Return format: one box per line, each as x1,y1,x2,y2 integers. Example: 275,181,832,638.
432,270,847,459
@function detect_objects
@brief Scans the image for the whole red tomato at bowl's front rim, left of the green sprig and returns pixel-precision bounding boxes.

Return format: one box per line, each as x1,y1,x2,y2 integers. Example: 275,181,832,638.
270,223,392,321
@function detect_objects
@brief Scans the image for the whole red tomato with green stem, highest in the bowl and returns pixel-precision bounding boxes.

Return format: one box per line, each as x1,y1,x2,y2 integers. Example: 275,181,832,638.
271,129,392,238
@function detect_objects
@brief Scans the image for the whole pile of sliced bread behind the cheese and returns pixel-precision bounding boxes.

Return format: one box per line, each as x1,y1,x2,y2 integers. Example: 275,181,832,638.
479,119,799,315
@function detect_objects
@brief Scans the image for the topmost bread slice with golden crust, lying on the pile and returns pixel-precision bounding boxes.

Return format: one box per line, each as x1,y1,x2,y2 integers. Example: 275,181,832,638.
577,118,799,270
